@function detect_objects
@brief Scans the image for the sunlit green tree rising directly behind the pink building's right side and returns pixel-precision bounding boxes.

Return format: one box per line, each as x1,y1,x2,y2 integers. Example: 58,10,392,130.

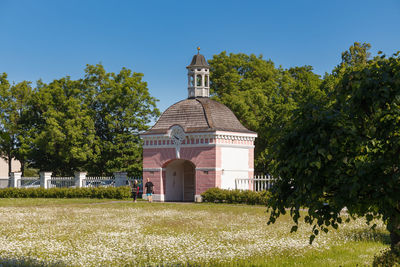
209,52,324,173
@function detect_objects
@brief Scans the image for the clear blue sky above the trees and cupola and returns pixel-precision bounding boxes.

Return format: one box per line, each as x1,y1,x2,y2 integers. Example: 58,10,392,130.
0,0,400,111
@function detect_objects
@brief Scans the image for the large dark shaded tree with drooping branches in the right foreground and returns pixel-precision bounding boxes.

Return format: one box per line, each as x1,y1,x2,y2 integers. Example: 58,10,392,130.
269,46,400,249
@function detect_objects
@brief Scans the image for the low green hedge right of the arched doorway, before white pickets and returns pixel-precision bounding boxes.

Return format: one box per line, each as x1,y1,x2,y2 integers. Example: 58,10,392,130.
201,188,270,205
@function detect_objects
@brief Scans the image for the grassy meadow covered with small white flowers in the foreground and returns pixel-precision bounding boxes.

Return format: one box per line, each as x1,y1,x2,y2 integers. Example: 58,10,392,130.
0,199,389,266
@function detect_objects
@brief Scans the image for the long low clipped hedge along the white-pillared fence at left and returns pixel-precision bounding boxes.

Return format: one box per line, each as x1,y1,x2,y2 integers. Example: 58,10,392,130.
0,186,130,199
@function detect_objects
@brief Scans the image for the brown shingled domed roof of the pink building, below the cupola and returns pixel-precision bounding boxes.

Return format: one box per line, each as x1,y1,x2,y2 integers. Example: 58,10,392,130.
145,98,254,135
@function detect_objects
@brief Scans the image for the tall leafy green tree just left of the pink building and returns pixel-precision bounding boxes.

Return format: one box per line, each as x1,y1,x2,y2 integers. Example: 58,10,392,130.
82,64,160,175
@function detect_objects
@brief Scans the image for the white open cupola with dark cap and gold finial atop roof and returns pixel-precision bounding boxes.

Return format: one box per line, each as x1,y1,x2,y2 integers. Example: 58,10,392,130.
186,47,210,98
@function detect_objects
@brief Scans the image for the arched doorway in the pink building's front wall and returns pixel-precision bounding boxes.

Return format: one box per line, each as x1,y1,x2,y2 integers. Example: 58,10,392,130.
165,159,196,201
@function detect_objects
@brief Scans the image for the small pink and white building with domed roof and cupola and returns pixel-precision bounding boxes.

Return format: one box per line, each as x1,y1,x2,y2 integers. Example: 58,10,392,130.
141,50,257,201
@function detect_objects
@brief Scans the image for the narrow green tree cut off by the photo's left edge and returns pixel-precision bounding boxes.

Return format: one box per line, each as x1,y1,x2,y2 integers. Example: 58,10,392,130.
0,73,32,176
